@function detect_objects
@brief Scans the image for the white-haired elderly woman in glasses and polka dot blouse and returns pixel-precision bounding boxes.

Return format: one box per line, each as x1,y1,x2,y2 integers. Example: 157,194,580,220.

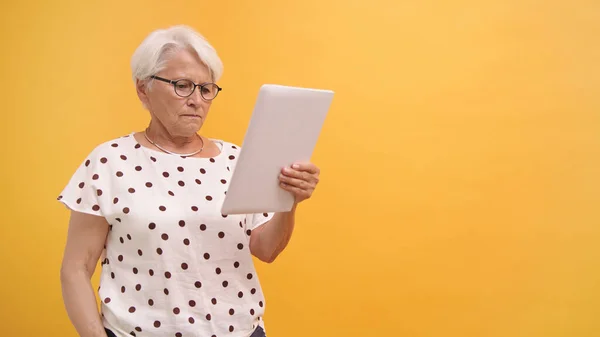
58,26,319,337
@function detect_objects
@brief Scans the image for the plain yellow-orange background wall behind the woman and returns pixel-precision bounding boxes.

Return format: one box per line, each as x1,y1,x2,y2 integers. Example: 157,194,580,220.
0,0,600,337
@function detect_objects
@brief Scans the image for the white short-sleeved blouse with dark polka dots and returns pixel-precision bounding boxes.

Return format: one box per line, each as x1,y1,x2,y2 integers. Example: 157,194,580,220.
58,133,273,337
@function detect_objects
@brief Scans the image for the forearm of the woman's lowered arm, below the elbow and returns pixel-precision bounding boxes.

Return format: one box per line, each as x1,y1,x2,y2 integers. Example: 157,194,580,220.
61,269,107,337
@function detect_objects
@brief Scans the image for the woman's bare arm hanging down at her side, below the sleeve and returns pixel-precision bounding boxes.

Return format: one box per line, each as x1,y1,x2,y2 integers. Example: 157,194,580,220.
60,211,109,337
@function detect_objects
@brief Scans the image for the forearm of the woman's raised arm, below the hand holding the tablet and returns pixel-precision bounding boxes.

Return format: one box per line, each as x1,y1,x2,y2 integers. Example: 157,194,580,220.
250,205,296,263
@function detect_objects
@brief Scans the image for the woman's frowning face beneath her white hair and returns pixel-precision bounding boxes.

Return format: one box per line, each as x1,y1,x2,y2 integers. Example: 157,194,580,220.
137,49,212,137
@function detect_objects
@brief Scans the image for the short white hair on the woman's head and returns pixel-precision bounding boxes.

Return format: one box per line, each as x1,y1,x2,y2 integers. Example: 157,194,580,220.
131,25,223,83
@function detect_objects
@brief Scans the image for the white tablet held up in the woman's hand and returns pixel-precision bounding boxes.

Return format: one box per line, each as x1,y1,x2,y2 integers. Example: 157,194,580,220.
221,84,333,214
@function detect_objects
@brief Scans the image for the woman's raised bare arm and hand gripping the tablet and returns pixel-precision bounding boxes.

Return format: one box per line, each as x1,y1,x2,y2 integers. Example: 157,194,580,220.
250,163,320,263
